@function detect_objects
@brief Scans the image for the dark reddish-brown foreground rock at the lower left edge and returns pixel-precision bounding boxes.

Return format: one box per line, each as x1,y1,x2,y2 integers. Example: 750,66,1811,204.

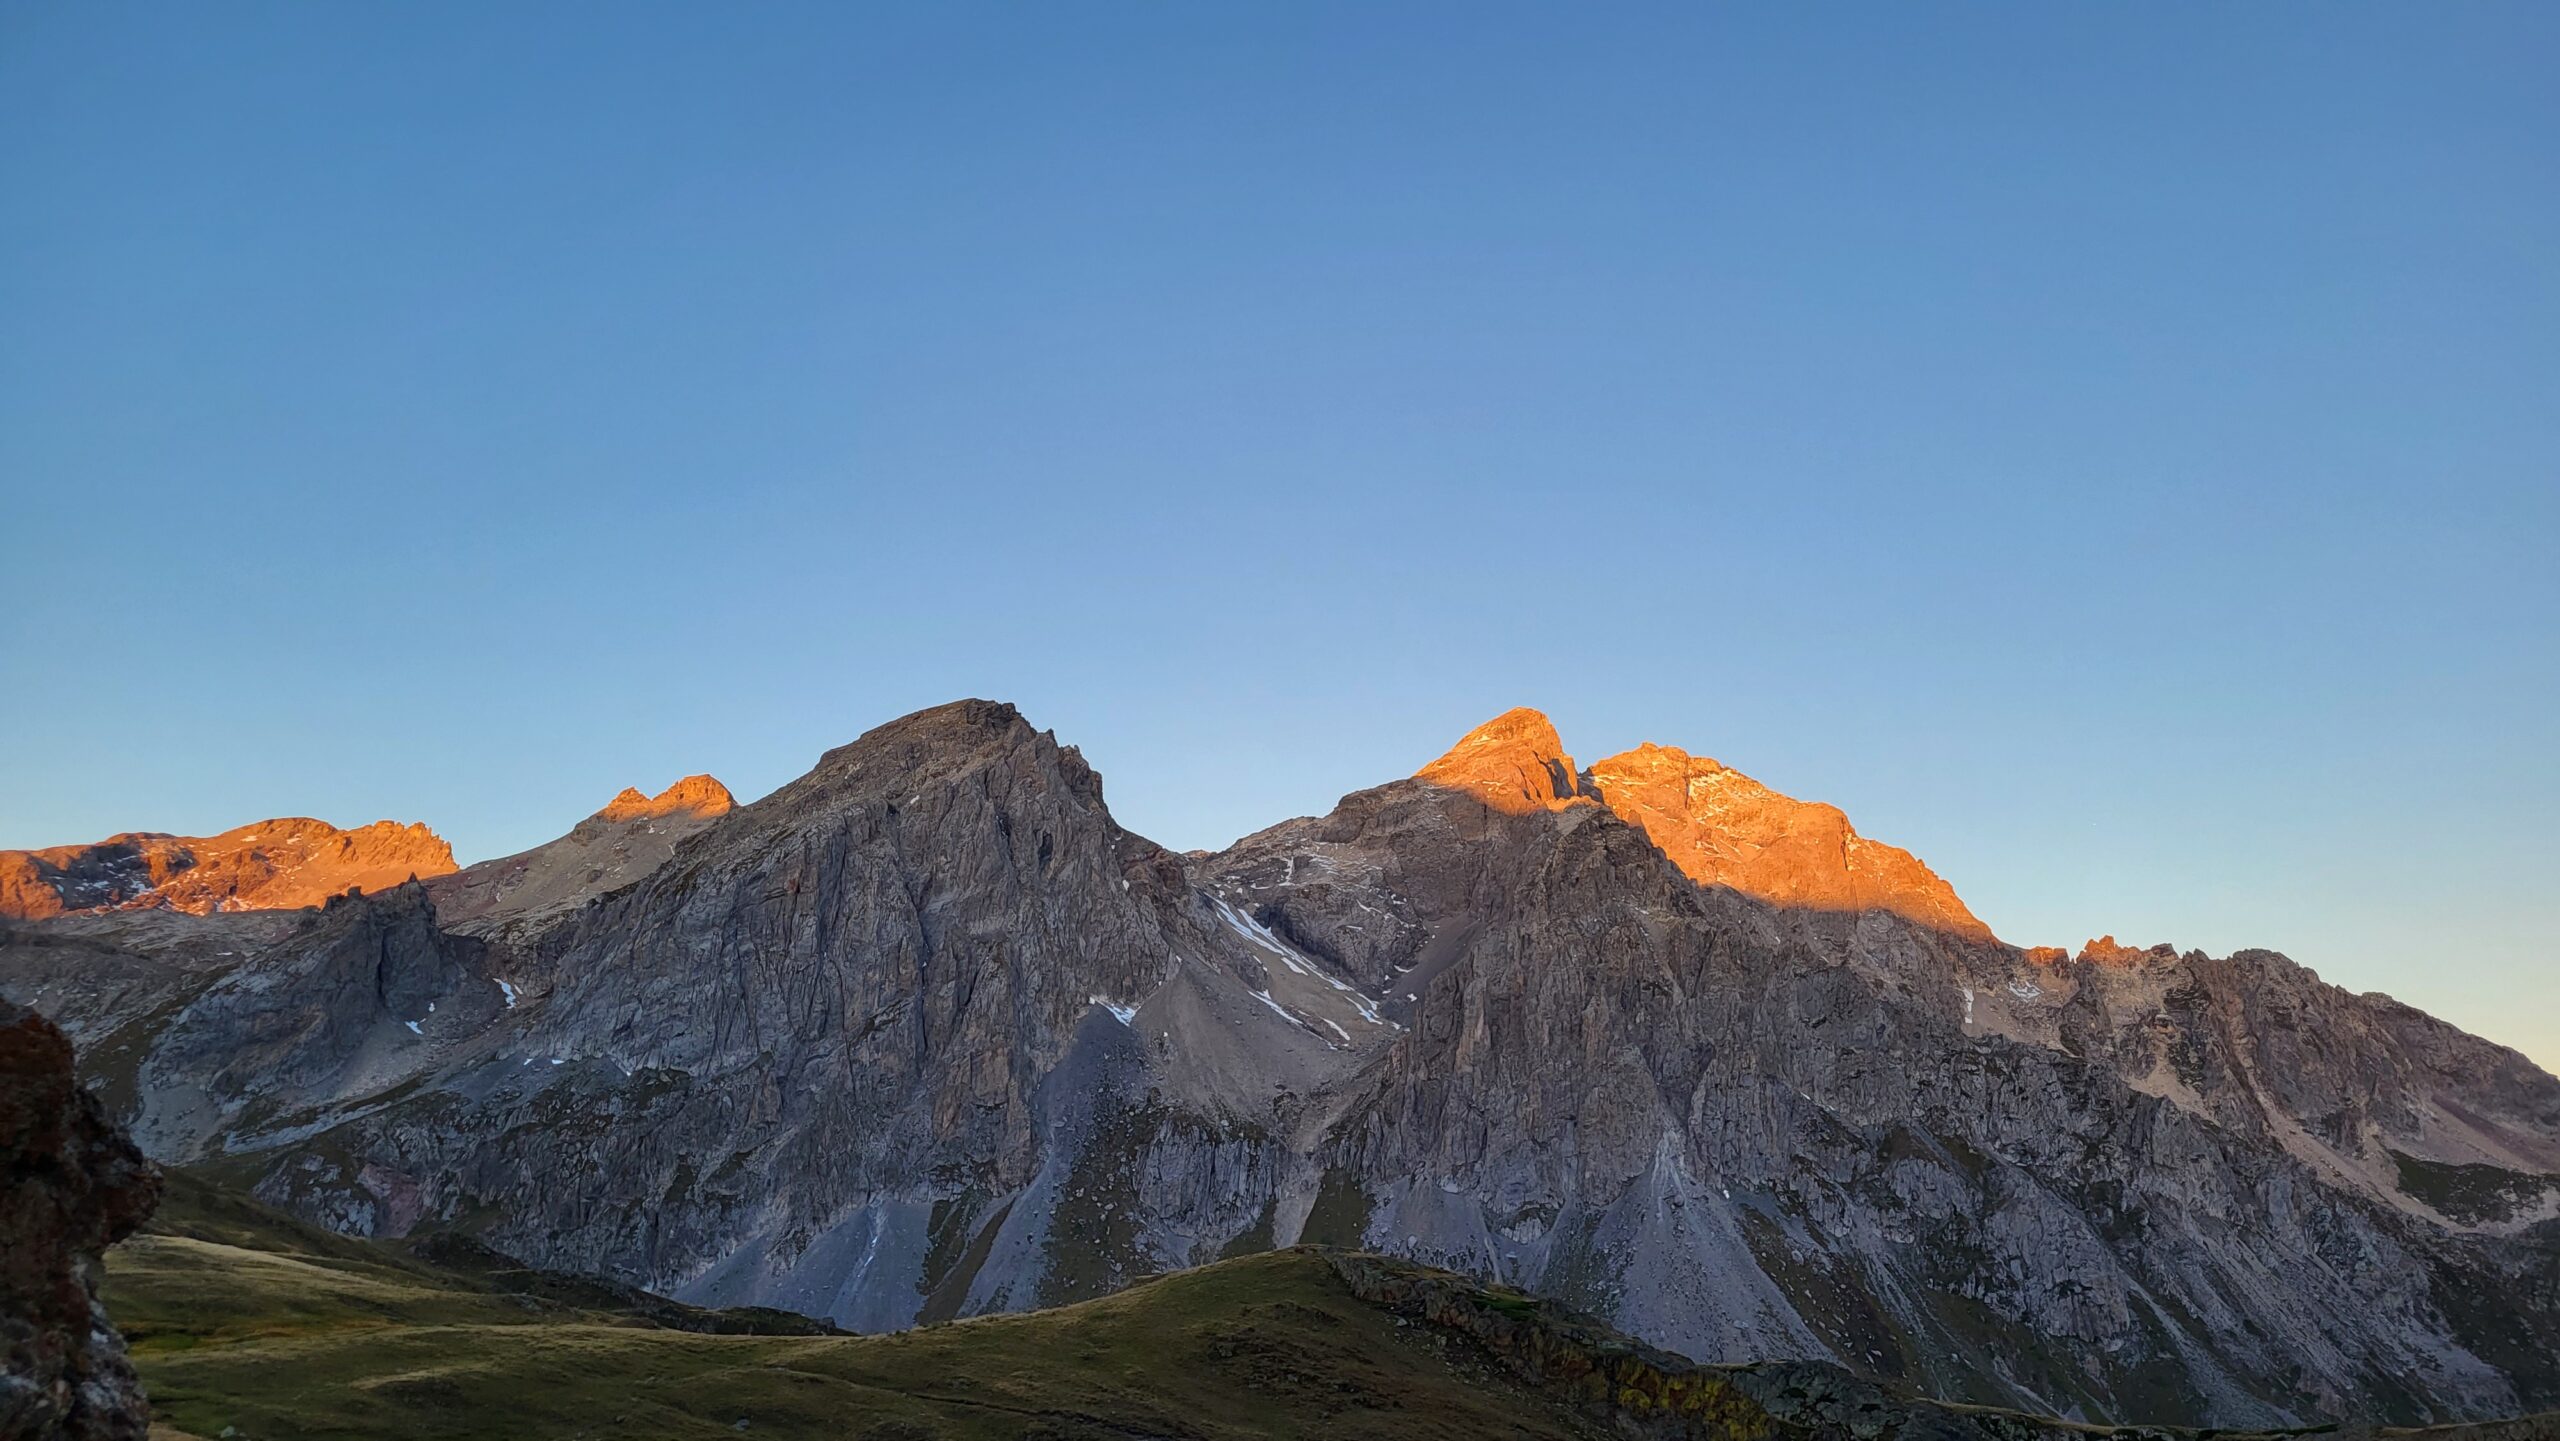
0,1001,159,1441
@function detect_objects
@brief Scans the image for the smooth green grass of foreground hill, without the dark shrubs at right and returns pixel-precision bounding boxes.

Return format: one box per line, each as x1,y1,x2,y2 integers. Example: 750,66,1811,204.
108,1177,1597,1441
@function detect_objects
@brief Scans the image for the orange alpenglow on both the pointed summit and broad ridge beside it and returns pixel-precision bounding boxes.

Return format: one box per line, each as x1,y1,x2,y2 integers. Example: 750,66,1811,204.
1416,706,1994,942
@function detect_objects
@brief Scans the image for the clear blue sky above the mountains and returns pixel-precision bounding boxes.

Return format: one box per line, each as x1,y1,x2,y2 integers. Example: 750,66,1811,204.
0,3,2560,1065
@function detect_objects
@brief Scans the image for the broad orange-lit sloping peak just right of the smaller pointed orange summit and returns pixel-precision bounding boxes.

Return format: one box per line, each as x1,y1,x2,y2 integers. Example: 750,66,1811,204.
1590,742,1992,939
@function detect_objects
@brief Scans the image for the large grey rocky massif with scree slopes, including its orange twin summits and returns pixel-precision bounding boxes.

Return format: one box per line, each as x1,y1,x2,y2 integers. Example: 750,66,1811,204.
0,701,2560,1423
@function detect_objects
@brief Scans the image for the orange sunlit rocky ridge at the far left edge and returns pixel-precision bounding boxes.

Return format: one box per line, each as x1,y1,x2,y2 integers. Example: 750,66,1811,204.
0,816,453,919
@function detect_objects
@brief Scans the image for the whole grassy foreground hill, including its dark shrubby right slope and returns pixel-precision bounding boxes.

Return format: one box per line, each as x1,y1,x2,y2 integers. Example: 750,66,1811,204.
105,1175,2532,1441
